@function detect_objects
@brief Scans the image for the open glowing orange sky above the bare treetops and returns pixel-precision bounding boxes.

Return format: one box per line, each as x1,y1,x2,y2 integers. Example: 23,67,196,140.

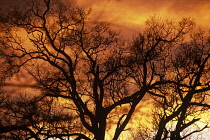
0,0,210,33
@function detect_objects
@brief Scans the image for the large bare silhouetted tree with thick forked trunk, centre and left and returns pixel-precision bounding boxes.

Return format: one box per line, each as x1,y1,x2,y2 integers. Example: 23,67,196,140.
1,0,208,140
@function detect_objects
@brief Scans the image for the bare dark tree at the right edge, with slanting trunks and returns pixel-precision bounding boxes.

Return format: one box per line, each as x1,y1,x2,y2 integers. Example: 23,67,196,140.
151,28,210,140
